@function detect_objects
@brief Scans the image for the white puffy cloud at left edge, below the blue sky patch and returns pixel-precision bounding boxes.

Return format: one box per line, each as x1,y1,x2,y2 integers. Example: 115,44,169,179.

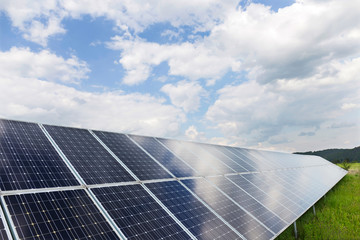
0,47,90,83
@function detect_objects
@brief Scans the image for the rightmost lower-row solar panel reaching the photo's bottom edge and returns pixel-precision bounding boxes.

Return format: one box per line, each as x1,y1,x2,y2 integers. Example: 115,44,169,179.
181,179,274,240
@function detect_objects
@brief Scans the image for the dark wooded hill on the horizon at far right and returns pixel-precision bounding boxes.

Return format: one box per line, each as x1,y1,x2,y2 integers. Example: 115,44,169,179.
295,146,360,163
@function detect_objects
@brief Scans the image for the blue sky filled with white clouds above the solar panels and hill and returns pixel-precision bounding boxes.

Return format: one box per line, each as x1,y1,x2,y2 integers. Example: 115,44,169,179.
0,0,360,152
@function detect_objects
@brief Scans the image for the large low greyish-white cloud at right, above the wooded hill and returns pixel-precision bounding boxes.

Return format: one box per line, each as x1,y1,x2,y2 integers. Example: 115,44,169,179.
206,58,360,148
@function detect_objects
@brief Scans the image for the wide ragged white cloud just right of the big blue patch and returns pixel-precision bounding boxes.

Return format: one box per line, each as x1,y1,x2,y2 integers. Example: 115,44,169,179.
108,36,232,85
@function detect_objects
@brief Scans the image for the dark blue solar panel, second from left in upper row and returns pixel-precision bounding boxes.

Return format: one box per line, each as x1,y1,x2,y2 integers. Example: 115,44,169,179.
44,125,135,184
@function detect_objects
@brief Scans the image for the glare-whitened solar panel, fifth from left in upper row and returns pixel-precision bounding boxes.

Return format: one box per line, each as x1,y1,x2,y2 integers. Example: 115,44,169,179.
158,138,221,176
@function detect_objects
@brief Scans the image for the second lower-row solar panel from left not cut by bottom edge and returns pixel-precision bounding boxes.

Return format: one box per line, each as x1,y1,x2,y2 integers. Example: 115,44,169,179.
227,175,296,224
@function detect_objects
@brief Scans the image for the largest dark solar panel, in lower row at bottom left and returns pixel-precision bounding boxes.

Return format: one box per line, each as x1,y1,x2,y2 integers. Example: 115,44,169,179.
4,190,119,239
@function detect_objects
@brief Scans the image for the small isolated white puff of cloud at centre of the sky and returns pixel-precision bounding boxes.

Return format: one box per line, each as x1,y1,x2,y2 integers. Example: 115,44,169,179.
161,81,206,112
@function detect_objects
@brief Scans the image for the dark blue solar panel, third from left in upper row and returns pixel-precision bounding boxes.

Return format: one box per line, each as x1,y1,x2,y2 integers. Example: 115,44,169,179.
94,131,172,180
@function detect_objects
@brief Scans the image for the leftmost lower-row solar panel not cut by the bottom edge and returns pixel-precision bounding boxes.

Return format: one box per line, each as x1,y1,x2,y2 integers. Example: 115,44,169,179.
205,177,287,232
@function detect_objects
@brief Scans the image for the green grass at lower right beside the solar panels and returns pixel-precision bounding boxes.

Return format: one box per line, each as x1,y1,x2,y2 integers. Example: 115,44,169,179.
276,163,360,240
